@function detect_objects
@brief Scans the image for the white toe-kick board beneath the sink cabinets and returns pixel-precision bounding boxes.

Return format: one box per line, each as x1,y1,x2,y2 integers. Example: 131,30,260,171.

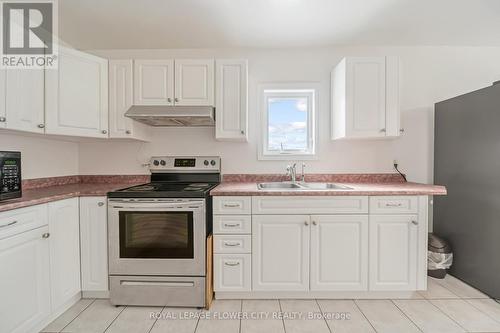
215,291,423,299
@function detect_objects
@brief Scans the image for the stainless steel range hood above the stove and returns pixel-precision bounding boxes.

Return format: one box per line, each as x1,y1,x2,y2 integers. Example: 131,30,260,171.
125,105,215,127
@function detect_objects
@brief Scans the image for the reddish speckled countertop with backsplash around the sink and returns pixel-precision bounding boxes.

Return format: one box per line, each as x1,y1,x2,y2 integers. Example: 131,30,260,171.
210,174,446,196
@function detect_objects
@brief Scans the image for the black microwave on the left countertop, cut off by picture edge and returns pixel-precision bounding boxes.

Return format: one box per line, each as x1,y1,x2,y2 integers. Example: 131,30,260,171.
0,151,22,201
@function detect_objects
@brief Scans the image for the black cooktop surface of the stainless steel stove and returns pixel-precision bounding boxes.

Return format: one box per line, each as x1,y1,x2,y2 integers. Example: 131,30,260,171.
108,182,217,198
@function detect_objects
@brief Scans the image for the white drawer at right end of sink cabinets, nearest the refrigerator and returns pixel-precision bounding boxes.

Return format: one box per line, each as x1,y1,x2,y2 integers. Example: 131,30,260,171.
370,196,418,214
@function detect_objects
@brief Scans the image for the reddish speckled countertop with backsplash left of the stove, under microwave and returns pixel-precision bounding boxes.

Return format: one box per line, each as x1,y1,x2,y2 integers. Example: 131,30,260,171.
0,176,149,212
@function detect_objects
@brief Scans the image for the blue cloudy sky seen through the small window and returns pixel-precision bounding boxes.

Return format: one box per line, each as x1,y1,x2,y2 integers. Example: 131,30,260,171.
267,97,308,151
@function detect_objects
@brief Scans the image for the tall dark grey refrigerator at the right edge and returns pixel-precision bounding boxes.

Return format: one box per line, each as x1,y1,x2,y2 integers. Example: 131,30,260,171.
434,84,500,299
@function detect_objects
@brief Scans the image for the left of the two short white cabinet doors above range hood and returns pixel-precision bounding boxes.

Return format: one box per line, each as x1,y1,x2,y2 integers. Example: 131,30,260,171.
134,59,174,105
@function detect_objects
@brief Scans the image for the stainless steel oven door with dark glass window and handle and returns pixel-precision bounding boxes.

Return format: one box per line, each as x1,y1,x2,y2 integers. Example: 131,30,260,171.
108,199,206,276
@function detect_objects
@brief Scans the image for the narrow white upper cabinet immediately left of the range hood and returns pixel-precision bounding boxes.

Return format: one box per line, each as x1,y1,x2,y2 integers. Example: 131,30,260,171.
109,60,148,141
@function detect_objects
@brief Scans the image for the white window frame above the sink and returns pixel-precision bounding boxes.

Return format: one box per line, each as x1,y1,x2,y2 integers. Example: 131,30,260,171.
258,83,319,160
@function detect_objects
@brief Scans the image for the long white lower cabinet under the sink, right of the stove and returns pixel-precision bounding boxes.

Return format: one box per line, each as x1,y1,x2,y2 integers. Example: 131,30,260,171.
214,196,428,298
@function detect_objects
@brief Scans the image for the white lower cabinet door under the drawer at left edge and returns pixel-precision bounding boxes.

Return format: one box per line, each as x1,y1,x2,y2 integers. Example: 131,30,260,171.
0,226,50,333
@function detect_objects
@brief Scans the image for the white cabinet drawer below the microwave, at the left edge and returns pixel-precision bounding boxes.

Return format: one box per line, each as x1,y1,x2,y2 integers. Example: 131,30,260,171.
0,204,48,239
